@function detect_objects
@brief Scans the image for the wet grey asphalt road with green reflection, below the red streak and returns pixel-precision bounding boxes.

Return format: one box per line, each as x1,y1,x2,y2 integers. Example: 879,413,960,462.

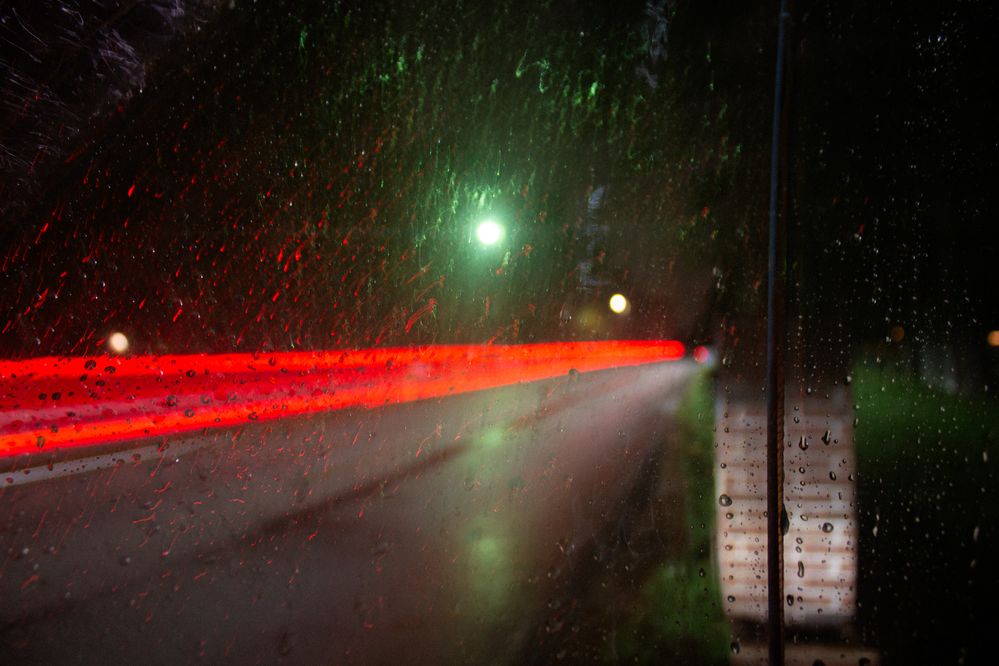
0,361,694,664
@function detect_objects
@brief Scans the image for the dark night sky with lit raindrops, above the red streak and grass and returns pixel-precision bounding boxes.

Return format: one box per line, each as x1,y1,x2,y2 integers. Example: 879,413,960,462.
0,0,997,366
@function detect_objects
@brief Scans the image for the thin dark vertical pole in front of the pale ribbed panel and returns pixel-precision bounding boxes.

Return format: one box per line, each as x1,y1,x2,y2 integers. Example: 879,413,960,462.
767,0,789,666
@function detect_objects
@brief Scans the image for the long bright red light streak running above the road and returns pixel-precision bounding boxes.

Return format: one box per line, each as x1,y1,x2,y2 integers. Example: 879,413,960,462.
0,340,684,457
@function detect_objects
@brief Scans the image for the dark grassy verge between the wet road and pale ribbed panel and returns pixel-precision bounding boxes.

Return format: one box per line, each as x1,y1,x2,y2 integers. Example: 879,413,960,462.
522,370,732,664
